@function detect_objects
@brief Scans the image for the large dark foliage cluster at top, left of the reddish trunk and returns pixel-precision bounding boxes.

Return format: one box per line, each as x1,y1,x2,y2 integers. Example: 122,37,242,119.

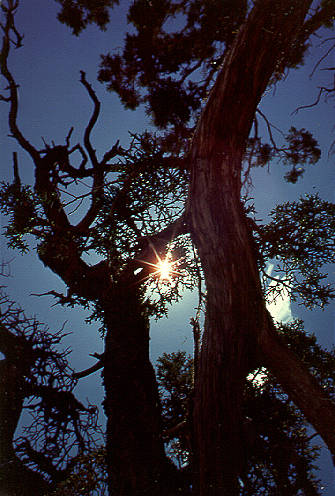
99,0,247,128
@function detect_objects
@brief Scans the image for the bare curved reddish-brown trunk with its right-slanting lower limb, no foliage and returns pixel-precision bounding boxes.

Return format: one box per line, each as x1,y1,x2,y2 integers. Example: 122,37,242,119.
187,0,335,496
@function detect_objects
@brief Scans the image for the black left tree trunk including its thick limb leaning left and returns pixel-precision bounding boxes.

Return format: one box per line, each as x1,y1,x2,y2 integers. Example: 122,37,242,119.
39,236,178,496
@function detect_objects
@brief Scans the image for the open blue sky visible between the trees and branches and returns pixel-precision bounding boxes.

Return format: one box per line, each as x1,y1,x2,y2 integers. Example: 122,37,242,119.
0,0,335,494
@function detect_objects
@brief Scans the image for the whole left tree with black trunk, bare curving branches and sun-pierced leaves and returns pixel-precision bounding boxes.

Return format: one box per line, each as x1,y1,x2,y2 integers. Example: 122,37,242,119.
1,0,196,496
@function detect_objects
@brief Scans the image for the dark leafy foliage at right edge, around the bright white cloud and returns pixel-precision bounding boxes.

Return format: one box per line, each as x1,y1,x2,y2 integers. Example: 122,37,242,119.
255,194,335,308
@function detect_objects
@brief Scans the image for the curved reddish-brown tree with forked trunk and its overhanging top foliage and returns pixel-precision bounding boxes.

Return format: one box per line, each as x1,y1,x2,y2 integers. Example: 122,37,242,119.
54,0,335,495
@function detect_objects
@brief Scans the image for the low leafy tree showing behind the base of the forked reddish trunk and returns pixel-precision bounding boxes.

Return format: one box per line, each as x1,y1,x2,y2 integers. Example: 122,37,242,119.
157,328,335,496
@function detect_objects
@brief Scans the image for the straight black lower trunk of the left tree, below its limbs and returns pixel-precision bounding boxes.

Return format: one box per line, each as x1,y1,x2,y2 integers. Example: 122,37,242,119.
103,281,182,496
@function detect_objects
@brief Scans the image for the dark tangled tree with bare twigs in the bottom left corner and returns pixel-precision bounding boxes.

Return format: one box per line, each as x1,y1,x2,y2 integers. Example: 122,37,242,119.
0,291,99,496
